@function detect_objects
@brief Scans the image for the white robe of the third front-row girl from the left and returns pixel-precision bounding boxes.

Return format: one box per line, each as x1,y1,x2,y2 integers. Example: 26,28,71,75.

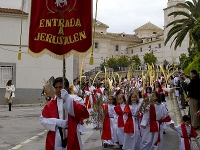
123,104,142,150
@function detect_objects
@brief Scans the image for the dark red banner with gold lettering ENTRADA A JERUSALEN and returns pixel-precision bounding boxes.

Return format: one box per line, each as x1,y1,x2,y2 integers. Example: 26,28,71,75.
29,0,92,59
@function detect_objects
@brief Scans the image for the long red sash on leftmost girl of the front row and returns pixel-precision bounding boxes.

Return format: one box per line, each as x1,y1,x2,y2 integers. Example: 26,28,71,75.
101,104,112,140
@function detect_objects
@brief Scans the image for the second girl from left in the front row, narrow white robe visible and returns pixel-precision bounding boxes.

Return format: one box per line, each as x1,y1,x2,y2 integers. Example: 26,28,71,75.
114,94,126,148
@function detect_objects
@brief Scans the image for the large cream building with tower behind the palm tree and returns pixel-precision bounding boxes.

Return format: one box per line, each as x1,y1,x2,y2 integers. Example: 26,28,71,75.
83,0,189,72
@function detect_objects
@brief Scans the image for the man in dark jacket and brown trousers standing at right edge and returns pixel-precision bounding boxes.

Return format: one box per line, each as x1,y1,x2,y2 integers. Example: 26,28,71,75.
187,70,200,129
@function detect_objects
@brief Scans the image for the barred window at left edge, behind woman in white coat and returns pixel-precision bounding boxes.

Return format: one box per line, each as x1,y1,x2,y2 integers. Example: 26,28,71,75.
0,66,13,87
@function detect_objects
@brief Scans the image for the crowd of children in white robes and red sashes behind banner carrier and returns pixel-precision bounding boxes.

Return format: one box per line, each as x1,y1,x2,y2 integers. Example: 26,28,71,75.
68,75,199,150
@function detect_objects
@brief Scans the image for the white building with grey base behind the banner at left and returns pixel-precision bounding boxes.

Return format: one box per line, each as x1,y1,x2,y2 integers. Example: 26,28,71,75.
0,1,78,104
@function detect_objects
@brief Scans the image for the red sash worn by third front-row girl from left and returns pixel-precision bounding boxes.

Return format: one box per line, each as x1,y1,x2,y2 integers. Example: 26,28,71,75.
124,105,134,133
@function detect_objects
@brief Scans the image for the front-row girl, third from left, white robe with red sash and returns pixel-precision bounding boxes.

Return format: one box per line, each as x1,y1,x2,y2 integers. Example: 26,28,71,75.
123,92,141,150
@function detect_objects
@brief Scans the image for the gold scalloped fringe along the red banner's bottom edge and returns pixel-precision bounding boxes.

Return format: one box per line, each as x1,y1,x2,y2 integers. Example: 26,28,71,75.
28,46,92,60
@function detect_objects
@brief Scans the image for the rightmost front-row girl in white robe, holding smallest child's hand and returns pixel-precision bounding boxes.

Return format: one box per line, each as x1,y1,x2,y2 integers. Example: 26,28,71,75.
141,92,173,150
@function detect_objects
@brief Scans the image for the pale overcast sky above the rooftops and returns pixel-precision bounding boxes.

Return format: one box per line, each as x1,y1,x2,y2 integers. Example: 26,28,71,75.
0,0,168,34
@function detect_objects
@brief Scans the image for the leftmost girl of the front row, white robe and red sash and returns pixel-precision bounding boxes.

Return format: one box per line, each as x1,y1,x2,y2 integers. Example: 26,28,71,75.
102,96,116,148
